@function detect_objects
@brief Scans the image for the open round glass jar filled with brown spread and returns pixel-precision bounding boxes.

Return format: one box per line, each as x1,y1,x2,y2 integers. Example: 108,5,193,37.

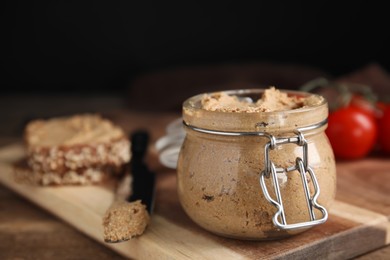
177,89,336,240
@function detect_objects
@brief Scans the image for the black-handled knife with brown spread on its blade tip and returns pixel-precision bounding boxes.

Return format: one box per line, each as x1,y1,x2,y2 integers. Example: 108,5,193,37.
103,130,156,243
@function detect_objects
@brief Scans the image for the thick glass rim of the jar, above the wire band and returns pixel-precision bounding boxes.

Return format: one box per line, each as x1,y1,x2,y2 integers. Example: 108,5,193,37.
183,88,328,132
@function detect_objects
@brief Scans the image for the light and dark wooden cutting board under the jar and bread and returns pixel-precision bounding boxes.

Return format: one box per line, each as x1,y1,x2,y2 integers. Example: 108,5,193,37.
0,144,390,259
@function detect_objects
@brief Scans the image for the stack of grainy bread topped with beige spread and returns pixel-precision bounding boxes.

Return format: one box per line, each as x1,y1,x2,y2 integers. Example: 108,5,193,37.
24,114,130,185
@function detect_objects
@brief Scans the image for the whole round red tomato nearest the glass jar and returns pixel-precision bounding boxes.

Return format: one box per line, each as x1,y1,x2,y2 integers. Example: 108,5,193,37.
326,106,378,159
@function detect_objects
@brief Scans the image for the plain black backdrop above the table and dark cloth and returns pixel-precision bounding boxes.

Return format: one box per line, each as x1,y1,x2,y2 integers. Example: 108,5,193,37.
1,1,390,93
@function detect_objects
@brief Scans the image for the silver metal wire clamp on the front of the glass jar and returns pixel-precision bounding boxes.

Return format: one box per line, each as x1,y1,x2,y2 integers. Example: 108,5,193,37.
260,131,328,230
